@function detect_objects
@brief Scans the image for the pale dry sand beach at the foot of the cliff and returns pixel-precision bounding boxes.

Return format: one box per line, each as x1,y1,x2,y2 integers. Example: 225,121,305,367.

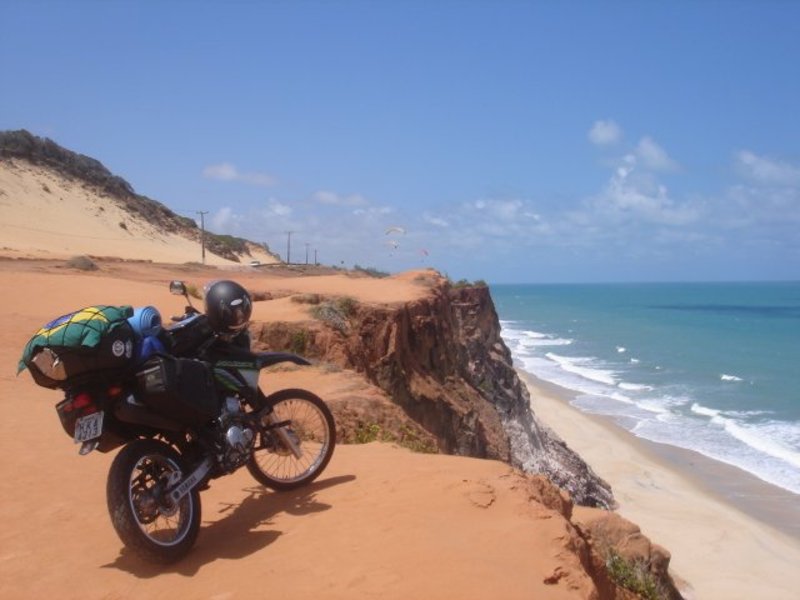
521,373,800,600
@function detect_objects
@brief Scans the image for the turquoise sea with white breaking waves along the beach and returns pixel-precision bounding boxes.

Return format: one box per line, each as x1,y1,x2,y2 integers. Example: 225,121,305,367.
491,282,800,494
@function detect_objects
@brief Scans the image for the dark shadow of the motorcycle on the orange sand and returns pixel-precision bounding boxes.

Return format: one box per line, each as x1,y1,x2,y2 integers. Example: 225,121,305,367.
102,475,355,579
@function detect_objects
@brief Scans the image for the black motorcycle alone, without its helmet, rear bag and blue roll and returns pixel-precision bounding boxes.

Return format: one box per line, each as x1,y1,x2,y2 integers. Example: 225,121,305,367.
34,281,336,564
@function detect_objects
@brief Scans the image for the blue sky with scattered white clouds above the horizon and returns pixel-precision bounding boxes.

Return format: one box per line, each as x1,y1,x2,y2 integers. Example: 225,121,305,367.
0,0,800,283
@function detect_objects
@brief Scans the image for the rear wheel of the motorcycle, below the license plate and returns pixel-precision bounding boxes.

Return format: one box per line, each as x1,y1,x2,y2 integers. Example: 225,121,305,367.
106,440,200,564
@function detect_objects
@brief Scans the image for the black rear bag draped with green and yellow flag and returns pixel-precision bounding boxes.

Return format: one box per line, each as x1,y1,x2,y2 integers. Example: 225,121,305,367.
17,306,134,388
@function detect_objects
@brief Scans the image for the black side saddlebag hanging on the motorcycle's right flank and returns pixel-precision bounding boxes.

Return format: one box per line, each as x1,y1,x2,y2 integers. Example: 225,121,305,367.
136,354,221,425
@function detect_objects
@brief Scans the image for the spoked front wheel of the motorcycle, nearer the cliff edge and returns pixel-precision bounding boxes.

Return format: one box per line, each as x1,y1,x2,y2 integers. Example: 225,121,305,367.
247,389,336,491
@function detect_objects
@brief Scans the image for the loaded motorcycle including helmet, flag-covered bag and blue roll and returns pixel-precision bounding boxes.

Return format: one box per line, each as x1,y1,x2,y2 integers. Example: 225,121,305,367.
20,281,336,564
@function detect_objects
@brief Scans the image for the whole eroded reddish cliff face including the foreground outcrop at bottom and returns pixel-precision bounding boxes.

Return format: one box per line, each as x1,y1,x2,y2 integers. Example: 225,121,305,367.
251,278,681,600
